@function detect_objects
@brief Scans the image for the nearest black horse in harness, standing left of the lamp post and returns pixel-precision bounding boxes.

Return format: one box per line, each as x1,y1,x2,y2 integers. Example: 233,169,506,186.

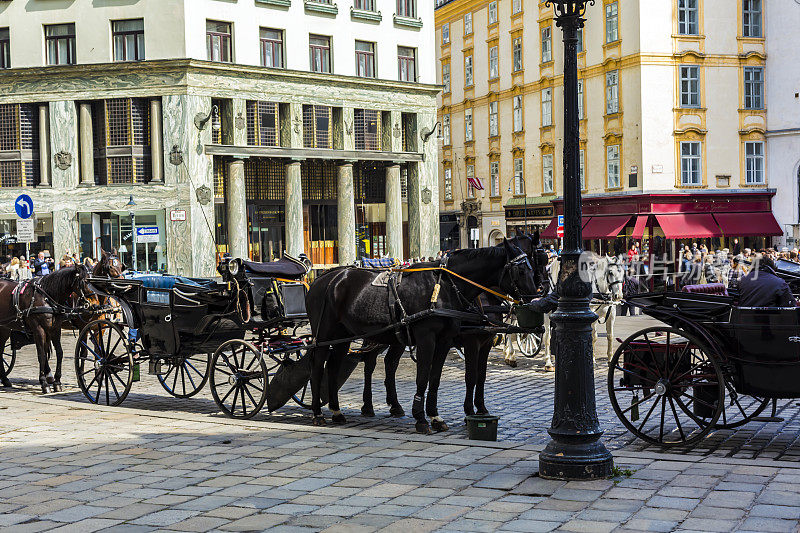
306,241,536,433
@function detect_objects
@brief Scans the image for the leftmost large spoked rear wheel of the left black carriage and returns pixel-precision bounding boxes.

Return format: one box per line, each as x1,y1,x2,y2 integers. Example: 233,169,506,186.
75,320,133,406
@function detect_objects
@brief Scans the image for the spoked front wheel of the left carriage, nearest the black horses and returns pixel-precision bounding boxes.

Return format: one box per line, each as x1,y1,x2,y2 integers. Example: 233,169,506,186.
209,339,268,418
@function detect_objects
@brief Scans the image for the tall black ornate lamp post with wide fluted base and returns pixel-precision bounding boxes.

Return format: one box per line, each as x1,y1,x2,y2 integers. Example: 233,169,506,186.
539,0,614,480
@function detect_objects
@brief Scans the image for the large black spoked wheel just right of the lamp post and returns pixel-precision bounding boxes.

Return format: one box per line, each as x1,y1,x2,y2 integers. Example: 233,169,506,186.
608,327,725,446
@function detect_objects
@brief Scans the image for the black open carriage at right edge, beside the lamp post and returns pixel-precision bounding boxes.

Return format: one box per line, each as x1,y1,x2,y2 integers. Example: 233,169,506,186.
608,261,800,446
